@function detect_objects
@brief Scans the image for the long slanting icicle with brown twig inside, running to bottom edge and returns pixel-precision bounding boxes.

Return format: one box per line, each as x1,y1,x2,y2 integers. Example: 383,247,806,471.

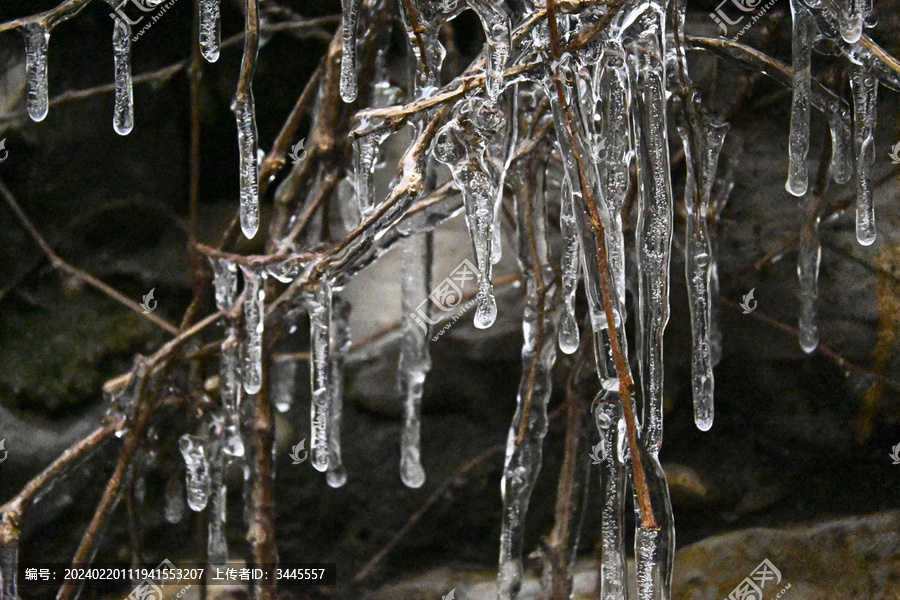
498,146,558,600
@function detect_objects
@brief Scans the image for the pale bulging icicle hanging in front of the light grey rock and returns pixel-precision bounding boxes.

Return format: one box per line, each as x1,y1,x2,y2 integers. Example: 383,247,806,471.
397,235,431,488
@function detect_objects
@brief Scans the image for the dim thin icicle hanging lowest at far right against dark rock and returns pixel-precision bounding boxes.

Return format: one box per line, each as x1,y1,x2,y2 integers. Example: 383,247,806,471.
797,195,822,354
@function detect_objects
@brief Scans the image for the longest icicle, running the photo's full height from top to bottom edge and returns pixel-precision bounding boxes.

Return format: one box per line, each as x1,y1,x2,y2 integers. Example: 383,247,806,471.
631,8,675,600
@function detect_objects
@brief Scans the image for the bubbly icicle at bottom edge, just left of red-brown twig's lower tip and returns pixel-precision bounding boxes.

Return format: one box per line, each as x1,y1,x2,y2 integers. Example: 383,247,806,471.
594,392,629,600
